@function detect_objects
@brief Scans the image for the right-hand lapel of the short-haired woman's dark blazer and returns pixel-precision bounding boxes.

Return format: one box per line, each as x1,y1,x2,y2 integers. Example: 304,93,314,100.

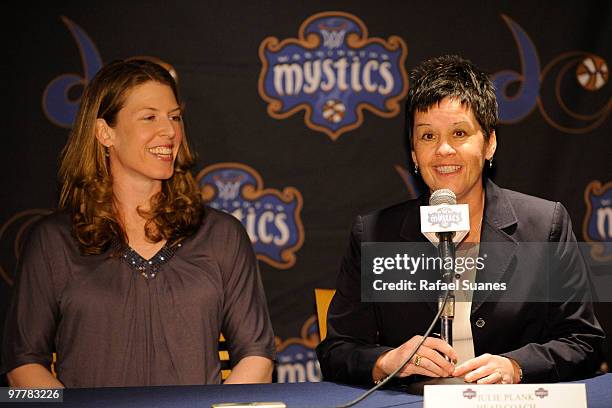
472,180,518,313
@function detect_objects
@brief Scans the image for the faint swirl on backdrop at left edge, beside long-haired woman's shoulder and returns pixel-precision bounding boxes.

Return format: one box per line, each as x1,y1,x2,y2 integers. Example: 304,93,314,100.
0,208,52,286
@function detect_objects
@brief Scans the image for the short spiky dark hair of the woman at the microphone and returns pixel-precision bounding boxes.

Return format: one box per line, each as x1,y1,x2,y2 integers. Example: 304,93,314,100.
406,55,498,146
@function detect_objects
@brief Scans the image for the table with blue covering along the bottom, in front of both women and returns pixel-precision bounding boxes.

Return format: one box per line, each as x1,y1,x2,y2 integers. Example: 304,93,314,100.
11,374,612,408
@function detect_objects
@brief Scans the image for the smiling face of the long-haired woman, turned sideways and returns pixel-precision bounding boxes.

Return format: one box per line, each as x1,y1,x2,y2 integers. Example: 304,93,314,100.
96,81,183,183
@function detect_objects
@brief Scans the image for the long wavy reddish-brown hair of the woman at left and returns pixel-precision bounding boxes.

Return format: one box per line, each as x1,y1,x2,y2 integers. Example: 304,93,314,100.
59,60,202,254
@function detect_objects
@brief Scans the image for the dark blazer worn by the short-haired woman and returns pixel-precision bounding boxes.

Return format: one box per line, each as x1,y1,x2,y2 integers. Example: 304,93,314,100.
317,181,604,384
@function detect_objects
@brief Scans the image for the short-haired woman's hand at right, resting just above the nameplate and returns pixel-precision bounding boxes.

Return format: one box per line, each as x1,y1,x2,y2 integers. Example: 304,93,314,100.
453,354,520,384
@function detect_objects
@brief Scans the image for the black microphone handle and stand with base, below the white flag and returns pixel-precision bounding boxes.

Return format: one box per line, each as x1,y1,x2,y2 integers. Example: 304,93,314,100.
407,233,467,395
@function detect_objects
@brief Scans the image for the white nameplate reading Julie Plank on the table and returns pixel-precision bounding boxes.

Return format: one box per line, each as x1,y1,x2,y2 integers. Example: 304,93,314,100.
423,384,587,408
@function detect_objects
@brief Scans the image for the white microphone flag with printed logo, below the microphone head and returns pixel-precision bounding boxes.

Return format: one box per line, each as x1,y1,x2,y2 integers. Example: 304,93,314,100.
421,204,470,245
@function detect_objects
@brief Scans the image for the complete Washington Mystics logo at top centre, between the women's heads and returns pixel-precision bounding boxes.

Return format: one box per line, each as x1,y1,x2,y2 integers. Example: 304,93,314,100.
259,11,408,140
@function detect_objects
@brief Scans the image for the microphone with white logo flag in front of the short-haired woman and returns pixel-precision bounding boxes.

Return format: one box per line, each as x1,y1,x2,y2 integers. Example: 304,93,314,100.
420,189,470,352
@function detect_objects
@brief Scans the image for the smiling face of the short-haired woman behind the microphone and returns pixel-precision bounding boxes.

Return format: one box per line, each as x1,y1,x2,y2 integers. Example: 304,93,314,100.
412,98,497,203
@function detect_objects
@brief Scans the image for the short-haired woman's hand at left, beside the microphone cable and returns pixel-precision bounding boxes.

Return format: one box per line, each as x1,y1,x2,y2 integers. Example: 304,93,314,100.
372,336,457,381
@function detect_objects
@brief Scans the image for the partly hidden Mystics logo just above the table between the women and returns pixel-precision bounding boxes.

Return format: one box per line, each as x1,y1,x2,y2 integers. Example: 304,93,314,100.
275,315,323,383
